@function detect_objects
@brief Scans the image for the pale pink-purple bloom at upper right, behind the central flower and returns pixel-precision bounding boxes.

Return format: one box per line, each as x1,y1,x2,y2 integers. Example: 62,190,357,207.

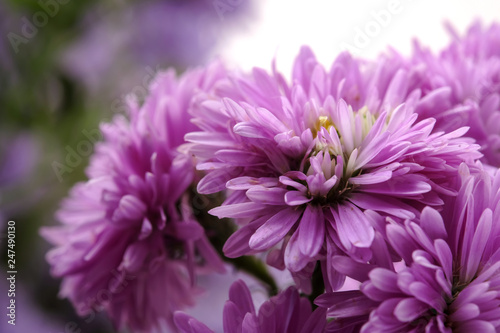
373,22,500,167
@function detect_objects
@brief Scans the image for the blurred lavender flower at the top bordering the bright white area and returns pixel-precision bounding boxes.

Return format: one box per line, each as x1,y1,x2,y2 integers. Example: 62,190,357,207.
129,0,252,67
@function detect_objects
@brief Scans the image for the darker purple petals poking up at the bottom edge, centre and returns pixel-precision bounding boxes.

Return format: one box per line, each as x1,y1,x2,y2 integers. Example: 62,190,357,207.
174,280,326,333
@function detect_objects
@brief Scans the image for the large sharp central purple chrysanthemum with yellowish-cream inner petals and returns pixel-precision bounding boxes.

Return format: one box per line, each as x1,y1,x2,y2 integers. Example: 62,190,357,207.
186,48,480,288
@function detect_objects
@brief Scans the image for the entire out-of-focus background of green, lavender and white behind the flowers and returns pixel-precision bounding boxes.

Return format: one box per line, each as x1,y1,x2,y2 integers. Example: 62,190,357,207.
0,0,500,333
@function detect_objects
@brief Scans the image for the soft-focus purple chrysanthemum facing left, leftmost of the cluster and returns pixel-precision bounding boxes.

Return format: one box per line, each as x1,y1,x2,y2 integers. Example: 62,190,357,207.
42,64,229,332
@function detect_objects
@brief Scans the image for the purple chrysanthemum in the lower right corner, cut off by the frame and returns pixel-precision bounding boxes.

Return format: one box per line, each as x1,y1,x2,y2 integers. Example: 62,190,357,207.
316,165,500,332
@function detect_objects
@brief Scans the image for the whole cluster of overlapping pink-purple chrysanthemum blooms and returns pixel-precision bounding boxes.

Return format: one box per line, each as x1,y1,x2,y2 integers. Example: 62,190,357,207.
42,20,500,333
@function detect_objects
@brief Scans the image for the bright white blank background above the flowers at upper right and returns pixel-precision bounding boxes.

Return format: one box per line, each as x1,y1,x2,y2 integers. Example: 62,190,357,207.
217,0,500,75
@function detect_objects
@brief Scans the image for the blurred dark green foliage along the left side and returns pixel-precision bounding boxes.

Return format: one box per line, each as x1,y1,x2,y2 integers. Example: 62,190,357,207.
0,0,137,333
